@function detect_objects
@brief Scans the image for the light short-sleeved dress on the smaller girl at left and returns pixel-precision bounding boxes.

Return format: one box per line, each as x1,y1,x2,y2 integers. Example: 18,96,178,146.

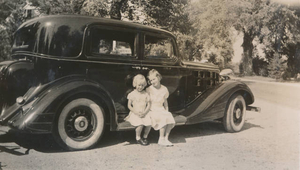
125,90,151,126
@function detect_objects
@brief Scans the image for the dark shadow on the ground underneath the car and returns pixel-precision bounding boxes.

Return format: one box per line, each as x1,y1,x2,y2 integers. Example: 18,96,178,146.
0,121,262,156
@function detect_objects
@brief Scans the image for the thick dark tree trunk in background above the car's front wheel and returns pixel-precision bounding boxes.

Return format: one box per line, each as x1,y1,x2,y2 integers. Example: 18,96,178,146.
240,31,254,76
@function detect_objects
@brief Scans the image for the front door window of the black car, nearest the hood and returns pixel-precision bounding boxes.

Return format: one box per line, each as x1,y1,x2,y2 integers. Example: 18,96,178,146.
144,35,176,61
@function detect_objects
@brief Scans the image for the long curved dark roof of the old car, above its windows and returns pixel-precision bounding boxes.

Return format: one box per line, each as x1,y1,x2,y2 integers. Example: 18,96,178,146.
19,15,174,37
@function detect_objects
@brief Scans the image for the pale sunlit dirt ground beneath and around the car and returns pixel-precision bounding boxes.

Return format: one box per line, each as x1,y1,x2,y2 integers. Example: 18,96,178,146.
0,81,300,170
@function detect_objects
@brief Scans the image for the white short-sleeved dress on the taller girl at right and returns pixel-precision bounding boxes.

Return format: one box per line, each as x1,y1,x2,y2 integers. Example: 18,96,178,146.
146,85,175,130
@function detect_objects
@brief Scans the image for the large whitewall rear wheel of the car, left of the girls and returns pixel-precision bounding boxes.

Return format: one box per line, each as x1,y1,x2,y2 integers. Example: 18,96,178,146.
54,98,104,150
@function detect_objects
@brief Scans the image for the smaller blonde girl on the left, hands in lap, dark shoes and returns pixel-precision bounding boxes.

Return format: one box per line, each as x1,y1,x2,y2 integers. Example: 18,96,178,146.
125,74,151,145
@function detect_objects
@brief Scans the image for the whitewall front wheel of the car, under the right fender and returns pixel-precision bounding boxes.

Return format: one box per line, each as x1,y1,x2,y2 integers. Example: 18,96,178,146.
223,94,246,132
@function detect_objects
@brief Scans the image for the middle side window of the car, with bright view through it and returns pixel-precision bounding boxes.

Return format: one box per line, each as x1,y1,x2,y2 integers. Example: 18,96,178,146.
89,27,135,58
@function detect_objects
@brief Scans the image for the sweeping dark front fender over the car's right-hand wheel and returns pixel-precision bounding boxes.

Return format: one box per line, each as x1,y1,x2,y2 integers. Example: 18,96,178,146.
183,81,254,124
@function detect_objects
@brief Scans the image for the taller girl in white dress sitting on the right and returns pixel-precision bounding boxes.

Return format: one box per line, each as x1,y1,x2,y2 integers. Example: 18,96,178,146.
146,69,175,146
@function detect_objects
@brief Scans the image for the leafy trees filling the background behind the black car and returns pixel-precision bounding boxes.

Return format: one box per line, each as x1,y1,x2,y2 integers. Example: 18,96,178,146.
0,0,300,77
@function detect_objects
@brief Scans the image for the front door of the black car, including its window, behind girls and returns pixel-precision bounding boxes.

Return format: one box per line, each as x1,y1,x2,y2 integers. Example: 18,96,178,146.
141,33,185,113
